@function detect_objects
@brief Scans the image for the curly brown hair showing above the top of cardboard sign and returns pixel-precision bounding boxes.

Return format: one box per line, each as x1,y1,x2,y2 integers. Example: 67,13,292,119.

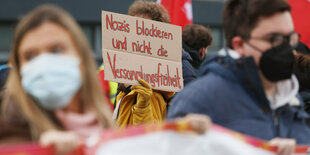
128,1,170,23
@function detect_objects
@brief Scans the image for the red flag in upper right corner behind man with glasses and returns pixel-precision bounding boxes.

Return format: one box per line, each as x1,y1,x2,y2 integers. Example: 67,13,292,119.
287,0,310,47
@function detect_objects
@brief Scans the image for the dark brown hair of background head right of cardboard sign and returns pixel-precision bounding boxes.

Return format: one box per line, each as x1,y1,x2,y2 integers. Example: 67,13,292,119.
182,24,213,51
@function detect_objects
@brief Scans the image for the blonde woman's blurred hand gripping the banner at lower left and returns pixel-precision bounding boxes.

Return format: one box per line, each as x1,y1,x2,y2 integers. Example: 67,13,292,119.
39,130,82,155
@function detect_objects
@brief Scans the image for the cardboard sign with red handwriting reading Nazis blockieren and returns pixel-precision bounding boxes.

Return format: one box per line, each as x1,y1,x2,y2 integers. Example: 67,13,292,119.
102,11,183,91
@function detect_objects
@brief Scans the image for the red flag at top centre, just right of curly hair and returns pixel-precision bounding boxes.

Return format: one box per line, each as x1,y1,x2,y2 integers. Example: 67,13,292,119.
157,0,193,29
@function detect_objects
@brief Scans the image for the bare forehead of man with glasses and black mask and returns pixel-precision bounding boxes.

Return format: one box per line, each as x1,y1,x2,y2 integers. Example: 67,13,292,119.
251,11,294,36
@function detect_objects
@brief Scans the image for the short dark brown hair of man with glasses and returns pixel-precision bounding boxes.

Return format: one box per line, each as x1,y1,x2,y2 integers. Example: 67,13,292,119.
223,0,291,48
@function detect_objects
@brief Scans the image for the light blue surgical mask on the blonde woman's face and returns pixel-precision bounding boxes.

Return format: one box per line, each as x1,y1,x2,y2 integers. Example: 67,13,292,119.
21,54,82,110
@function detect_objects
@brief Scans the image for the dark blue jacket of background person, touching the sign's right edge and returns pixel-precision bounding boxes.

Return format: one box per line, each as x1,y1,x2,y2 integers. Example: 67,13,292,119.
182,49,197,86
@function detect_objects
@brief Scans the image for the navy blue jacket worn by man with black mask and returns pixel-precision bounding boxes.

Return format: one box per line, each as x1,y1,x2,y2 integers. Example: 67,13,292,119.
168,51,310,144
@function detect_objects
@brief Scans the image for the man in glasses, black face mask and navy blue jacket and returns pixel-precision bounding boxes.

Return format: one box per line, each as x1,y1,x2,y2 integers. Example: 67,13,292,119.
168,0,310,154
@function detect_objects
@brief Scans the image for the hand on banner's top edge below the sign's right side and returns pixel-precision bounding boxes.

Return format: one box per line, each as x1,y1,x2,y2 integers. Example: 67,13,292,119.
177,114,212,134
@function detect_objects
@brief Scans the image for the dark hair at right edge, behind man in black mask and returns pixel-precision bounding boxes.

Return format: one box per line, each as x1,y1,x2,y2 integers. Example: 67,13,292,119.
294,52,310,91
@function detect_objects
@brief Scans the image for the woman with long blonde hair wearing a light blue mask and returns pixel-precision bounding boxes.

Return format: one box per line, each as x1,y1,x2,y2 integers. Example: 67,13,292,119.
0,5,113,154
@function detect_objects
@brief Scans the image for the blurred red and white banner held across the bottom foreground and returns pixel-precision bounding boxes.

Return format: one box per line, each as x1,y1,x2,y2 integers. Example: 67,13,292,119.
0,122,309,155
